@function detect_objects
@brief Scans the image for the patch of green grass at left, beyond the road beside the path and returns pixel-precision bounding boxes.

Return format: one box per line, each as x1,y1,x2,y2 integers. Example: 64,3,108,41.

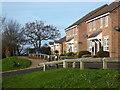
1,56,31,71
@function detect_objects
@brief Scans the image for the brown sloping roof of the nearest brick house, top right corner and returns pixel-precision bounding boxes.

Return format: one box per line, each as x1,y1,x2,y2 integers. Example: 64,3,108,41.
88,0,120,20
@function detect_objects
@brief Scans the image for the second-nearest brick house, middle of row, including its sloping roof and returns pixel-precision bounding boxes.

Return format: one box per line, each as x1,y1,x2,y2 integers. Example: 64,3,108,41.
65,5,107,52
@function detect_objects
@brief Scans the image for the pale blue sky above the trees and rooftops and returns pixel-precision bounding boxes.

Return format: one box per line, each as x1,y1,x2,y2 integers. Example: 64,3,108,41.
2,2,114,45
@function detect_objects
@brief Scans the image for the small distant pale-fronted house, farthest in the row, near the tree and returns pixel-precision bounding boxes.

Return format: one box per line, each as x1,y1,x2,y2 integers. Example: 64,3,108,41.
49,36,66,55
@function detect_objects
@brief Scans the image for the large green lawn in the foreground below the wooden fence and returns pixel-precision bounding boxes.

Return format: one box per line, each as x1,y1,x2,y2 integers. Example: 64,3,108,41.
3,68,120,88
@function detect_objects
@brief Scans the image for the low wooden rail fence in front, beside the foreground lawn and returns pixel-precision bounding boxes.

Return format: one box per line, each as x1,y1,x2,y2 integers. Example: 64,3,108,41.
39,58,119,71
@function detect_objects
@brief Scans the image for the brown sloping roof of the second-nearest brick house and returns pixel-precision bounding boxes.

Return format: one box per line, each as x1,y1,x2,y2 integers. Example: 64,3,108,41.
65,4,107,30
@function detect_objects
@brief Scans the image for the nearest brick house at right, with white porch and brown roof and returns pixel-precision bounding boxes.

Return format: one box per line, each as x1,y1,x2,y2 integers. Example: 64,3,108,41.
86,2,120,57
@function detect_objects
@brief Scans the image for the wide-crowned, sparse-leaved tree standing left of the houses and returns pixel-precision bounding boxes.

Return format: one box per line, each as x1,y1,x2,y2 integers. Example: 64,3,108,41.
23,20,60,48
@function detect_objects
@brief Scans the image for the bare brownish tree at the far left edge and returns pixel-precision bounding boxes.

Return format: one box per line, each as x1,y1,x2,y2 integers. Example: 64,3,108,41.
2,20,25,57
